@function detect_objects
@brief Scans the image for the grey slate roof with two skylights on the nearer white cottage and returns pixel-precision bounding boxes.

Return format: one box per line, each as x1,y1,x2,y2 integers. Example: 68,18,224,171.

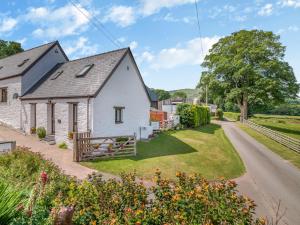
22,48,130,99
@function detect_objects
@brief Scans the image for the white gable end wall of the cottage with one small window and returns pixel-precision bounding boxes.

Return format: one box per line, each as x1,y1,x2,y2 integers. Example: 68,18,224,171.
91,54,150,138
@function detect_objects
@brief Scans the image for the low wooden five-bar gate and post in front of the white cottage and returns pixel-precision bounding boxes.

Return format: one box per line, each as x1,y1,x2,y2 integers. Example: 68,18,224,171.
73,132,136,162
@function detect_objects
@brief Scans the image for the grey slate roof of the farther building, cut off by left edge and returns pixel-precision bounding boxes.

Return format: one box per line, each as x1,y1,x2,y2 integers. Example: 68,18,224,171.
0,41,57,79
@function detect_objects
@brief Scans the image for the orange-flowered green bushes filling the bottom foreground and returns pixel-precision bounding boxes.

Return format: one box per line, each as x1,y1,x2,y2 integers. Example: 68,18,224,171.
0,151,265,225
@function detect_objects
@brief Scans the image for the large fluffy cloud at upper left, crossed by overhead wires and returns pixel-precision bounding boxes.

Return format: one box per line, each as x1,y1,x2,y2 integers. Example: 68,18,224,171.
24,4,91,39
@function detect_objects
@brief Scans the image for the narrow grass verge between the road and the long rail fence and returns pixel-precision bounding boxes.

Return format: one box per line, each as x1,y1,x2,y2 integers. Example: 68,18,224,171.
238,123,300,168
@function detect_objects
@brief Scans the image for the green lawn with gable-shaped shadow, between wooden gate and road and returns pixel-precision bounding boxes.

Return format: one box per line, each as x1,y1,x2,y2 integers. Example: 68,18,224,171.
82,124,245,179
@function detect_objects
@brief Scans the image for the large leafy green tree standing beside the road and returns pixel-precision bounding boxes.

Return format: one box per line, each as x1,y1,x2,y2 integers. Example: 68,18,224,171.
199,30,299,119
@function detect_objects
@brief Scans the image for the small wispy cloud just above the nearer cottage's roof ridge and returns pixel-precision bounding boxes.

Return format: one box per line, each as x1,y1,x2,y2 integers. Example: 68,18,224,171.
64,37,99,58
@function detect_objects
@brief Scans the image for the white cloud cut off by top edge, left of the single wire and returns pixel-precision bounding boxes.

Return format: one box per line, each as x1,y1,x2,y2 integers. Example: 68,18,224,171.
140,0,195,16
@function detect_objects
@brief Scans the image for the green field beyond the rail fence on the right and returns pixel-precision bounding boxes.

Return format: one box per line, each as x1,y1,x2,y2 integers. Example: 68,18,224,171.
250,114,300,139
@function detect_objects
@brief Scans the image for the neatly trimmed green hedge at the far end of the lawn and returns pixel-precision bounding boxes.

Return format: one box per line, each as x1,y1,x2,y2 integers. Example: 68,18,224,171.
177,103,210,127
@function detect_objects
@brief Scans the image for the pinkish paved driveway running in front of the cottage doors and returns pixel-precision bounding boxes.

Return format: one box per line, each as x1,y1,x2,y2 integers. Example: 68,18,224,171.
0,125,118,179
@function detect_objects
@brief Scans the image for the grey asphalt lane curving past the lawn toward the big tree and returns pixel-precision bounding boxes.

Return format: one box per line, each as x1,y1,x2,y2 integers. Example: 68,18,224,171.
221,122,300,225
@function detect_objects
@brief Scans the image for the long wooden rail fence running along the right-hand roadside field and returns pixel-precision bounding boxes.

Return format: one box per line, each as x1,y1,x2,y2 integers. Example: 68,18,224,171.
244,120,300,153
